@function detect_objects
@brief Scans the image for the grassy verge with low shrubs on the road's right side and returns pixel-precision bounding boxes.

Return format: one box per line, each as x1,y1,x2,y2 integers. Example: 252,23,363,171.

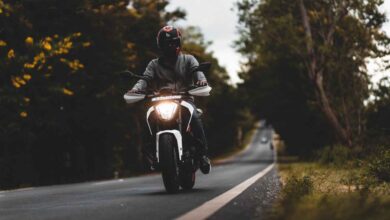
270,138,390,220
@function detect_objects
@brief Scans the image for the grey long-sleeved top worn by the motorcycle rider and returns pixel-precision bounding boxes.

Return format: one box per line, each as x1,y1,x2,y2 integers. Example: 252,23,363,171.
133,53,206,91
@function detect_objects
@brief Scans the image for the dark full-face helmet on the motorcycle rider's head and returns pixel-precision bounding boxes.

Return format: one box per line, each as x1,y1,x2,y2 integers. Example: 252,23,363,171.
157,26,181,57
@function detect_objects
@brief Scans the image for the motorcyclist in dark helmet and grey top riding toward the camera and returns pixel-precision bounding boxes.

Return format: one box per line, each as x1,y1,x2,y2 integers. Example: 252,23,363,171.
128,26,211,174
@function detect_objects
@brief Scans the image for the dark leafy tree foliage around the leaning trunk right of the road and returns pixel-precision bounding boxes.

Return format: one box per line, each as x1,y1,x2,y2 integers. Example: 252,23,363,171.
237,0,389,154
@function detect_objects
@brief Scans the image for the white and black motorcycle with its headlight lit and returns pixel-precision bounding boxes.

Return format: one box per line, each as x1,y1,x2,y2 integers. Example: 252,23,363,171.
123,63,212,193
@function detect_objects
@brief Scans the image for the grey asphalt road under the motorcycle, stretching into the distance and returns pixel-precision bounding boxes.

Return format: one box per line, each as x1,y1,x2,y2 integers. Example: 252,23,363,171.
0,129,275,220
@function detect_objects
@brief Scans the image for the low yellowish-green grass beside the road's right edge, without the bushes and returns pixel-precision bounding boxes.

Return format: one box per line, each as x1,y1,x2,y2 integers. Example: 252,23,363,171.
271,156,390,220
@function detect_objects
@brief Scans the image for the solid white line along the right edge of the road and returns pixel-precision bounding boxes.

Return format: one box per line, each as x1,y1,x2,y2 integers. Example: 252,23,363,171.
177,163,275,220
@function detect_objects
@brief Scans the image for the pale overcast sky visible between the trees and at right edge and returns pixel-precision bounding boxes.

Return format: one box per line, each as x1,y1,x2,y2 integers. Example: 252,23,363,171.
167,0,390,84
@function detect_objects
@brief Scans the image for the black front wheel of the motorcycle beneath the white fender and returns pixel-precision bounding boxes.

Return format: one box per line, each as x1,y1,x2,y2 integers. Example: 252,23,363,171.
159,134,180,193
